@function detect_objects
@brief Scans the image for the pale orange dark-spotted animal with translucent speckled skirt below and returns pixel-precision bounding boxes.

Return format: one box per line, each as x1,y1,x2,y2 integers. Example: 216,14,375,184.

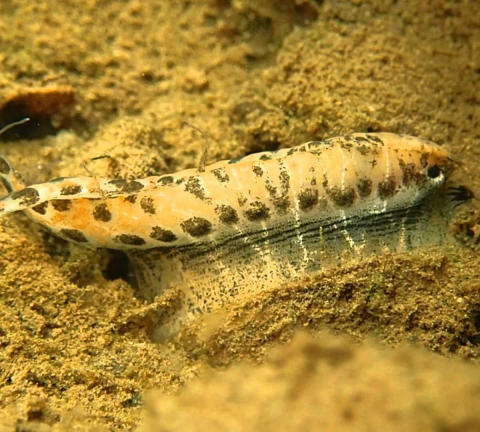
0,133,466,336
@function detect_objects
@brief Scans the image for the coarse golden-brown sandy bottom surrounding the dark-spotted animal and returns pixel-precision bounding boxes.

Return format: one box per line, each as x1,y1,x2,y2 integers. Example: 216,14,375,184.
0,0,480,431
